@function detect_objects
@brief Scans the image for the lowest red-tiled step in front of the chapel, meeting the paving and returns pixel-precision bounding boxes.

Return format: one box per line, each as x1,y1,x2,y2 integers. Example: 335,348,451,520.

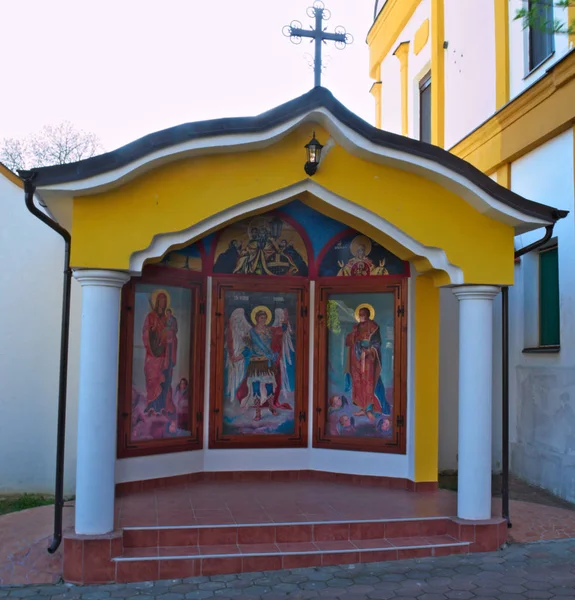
113,535,470,583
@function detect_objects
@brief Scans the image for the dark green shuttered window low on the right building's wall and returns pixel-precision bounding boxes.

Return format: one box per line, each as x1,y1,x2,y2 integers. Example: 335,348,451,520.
539,246,559,346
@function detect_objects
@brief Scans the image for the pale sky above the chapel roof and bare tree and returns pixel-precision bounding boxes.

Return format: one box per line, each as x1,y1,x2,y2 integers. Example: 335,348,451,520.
0,0,374,150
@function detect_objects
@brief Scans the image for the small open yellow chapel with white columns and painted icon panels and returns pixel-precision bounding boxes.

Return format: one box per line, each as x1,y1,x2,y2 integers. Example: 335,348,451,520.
27,86,557,583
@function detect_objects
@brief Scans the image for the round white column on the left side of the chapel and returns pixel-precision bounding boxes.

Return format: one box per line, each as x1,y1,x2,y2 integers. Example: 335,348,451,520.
74,269,130,535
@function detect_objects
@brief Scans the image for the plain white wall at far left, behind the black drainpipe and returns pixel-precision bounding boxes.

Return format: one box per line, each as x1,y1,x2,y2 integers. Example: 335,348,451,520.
0,174,78,494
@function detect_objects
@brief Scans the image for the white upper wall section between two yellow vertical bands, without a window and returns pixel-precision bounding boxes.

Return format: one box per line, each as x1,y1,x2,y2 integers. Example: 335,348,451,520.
444,0,496,148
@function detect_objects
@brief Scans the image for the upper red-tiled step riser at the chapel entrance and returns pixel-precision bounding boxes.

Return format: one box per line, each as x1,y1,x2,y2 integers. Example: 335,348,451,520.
123,517,457,548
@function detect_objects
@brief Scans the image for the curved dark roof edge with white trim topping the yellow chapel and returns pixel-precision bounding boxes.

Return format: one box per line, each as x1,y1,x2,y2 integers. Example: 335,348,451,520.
27,88,567,233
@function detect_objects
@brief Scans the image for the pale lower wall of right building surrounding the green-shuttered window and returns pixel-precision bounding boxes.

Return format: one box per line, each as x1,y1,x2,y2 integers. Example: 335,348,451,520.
510,130,575,501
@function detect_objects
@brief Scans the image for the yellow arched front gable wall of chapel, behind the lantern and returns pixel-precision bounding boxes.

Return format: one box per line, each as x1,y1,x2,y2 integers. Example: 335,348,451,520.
72,127,513,284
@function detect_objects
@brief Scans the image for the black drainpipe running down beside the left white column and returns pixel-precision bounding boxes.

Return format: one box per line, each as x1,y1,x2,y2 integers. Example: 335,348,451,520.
18,171,72,554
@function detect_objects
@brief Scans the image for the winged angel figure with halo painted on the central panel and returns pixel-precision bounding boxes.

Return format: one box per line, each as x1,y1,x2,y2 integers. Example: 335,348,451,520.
226,306,294,421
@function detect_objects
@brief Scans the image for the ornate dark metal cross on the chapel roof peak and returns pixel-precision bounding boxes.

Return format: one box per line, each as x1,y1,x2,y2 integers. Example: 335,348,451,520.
283,0,353,87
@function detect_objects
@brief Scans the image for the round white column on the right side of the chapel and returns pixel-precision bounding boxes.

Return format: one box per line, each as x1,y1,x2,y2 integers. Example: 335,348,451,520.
453,285,499,520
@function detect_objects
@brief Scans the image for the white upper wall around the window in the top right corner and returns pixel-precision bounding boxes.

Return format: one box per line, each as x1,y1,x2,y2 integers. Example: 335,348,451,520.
510,0,569,99
